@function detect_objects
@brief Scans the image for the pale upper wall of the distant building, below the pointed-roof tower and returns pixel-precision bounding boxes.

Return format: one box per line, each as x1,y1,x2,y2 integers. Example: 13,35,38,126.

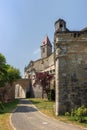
25,53,55,78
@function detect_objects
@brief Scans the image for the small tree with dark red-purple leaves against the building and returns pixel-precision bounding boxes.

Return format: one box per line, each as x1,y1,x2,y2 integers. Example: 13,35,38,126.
34,72,54,98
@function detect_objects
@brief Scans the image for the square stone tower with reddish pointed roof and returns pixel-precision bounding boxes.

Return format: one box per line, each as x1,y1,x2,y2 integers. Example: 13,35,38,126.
41,36,52,58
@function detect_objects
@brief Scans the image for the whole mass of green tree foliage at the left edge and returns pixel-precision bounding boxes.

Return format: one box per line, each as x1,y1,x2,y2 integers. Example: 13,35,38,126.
0,53,21,87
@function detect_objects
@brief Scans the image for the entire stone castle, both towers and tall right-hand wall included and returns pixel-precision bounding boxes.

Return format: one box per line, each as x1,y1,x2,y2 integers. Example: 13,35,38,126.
25,19,87,115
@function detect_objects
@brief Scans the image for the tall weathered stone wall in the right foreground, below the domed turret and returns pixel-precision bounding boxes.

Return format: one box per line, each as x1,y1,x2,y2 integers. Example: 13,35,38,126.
55,32,87,113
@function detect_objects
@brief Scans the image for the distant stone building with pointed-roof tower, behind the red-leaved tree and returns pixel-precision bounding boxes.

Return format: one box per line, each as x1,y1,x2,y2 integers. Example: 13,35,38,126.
24,36,55,98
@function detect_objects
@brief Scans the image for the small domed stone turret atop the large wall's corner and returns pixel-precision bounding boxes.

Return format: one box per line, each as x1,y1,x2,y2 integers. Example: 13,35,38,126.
55,19,67,32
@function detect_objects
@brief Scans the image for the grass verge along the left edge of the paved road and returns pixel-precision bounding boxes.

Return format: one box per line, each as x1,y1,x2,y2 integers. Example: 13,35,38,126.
0,99,18,130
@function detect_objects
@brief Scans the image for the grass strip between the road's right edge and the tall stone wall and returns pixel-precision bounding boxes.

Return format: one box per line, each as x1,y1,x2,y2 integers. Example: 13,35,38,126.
29,98,87,127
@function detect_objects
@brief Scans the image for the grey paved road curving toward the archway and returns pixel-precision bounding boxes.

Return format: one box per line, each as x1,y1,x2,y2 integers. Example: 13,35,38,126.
11,99,84,130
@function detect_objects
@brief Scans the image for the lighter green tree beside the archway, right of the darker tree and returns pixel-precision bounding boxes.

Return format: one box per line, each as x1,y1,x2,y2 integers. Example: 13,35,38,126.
7,65,21,85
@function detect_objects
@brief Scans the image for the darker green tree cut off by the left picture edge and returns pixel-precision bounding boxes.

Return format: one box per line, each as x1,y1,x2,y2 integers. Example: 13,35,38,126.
0,53,7,87
